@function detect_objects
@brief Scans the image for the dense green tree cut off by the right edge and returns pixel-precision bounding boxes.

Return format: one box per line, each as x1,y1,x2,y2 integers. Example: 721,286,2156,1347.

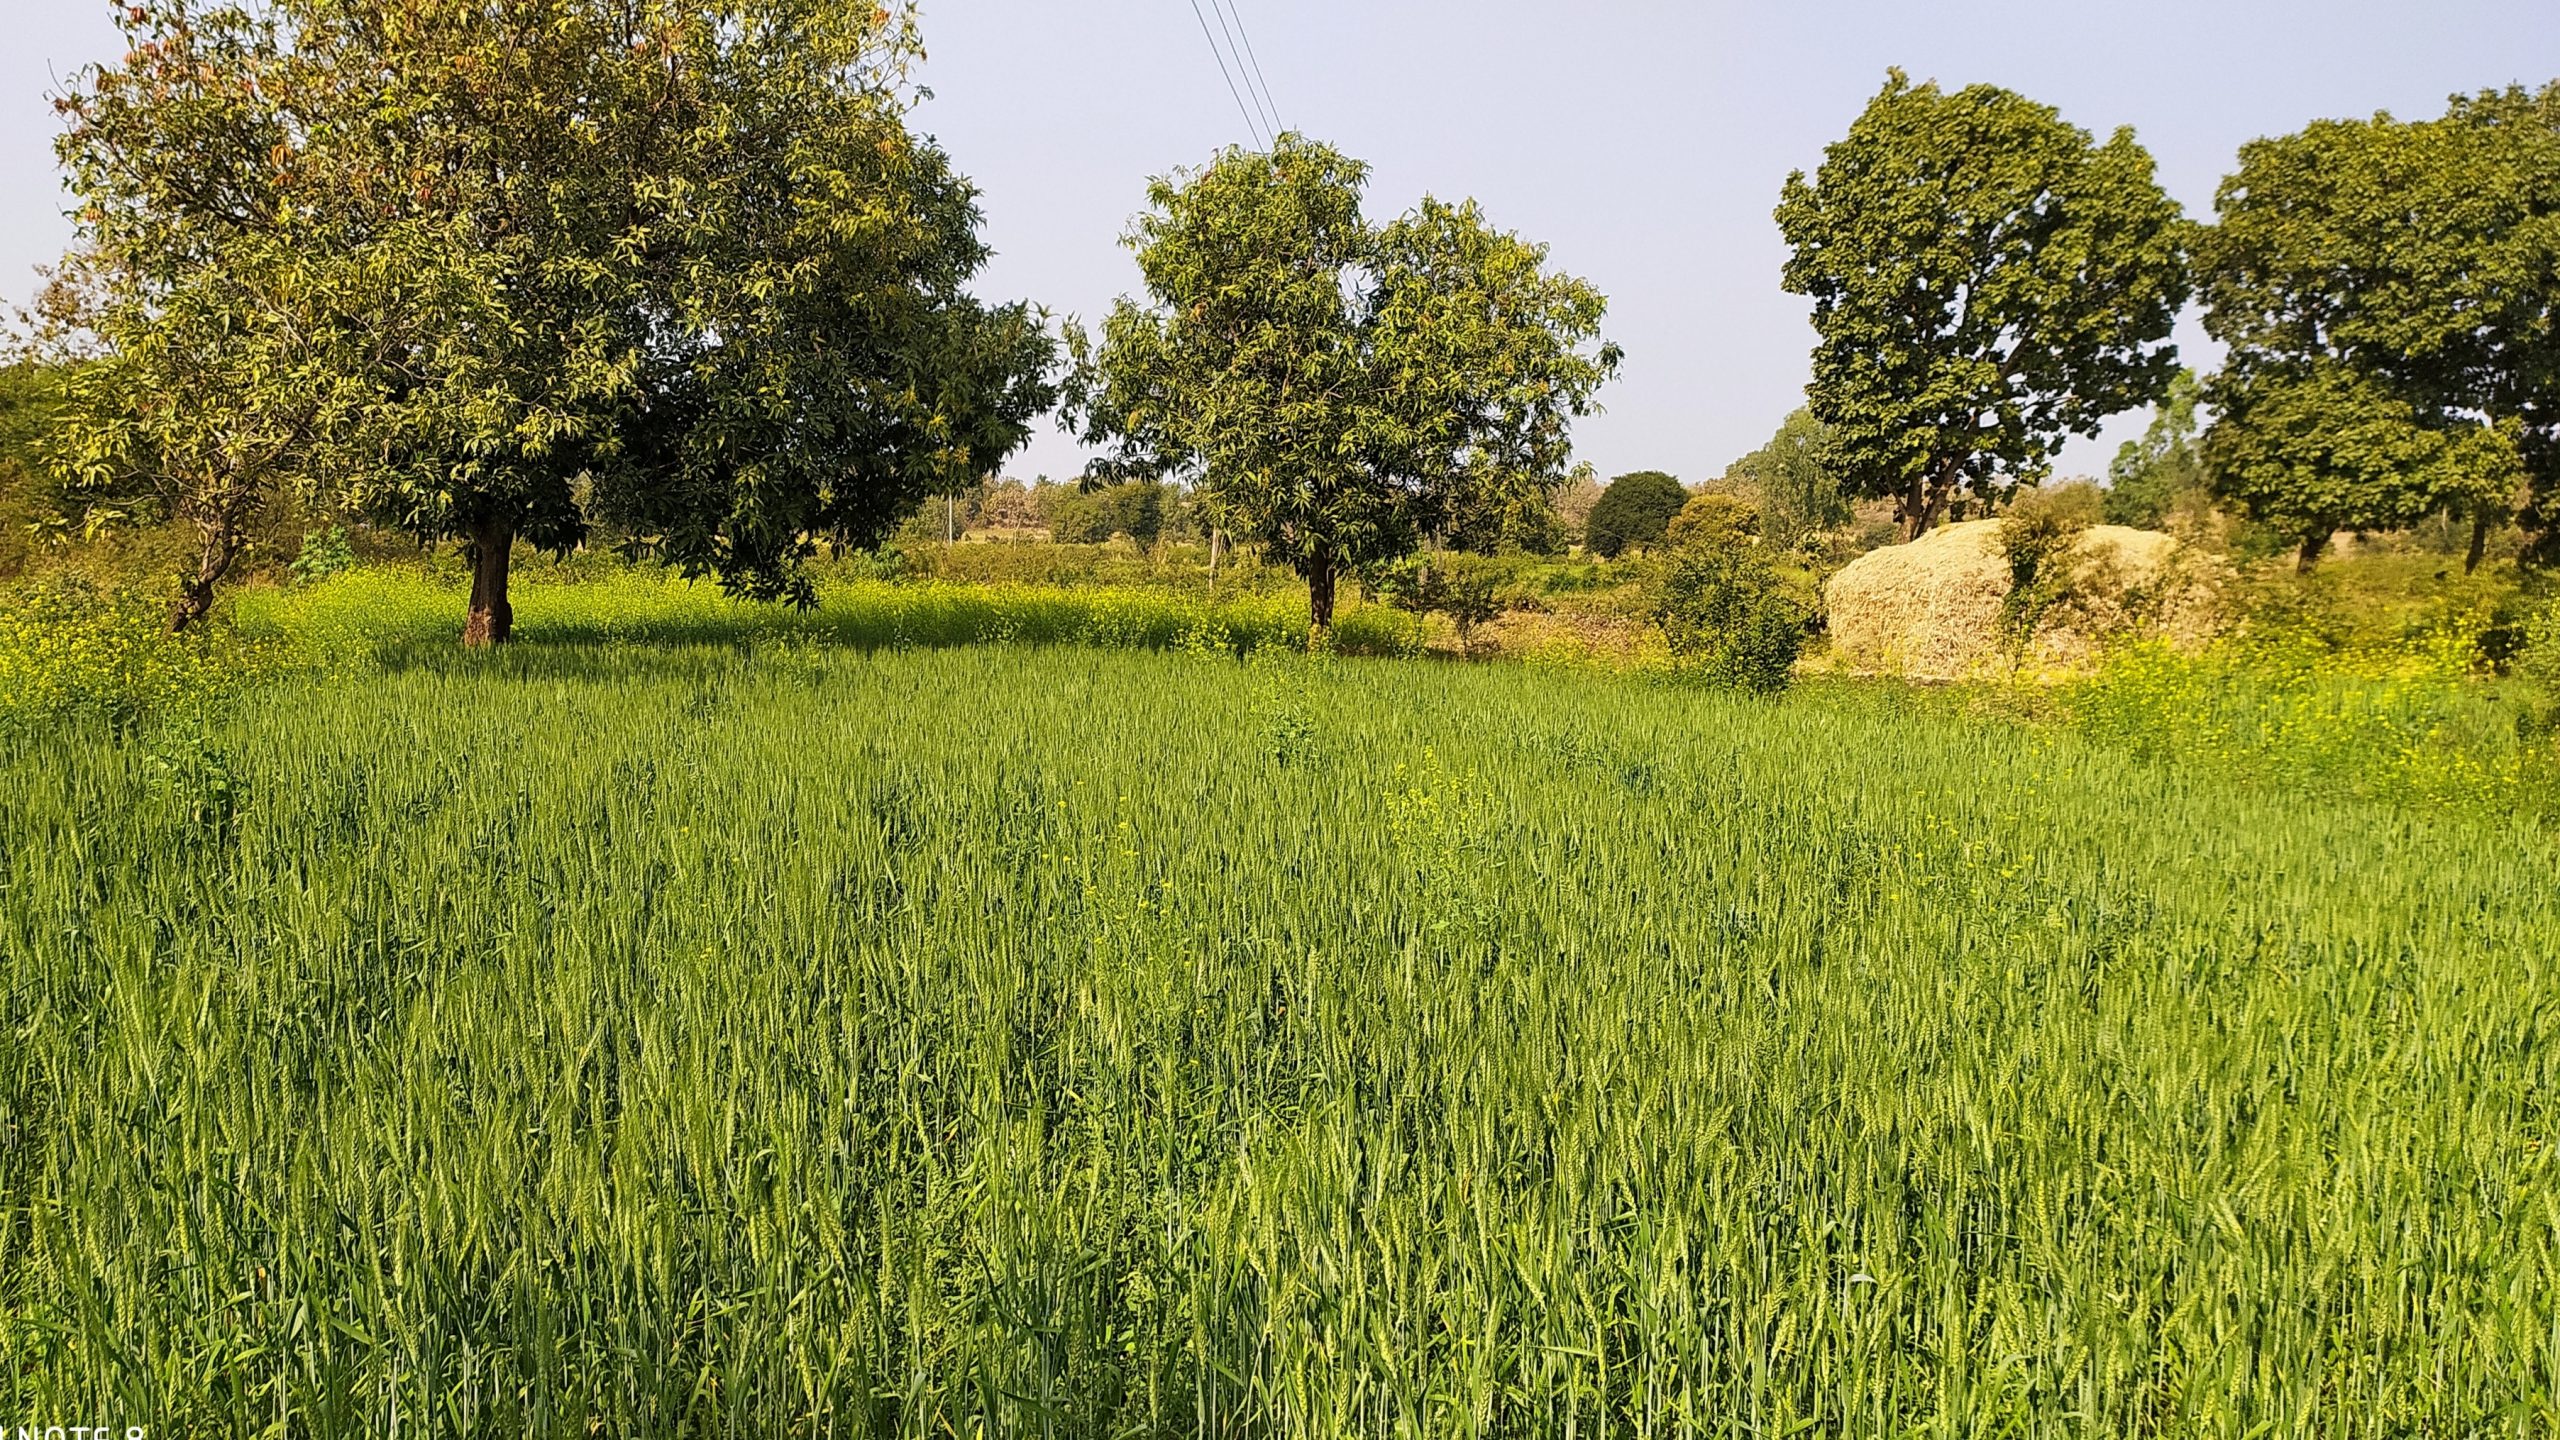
2196,85,2560,564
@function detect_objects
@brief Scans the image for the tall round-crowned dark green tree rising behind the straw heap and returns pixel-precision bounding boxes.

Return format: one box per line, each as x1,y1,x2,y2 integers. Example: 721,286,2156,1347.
1777,72,2189,538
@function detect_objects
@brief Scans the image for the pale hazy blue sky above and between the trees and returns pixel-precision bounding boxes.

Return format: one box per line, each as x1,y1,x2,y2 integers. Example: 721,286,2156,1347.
0,0,2560,479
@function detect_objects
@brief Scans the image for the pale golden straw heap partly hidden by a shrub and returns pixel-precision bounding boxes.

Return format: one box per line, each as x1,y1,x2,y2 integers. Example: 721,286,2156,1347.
1825,520,2214,679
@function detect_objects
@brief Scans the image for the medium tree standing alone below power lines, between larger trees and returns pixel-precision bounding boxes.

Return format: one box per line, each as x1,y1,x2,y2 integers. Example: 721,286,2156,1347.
1070,136,1618,630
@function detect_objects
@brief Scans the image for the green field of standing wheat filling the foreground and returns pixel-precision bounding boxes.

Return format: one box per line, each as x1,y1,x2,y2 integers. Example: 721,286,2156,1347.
0,609,2560,1437
